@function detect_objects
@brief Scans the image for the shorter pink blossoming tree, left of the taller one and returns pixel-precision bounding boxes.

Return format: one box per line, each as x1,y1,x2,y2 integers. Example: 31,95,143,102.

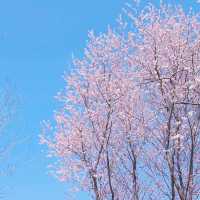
42,29,148,200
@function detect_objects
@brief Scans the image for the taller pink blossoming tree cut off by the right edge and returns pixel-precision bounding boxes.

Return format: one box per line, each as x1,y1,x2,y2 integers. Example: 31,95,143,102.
129,3,200,200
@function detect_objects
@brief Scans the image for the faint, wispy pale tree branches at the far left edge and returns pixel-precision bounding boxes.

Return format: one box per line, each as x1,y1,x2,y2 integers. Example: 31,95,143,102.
0,82,17,199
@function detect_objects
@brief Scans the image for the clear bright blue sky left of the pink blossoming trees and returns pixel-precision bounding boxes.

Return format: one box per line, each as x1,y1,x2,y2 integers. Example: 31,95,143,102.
0,0,197,200
